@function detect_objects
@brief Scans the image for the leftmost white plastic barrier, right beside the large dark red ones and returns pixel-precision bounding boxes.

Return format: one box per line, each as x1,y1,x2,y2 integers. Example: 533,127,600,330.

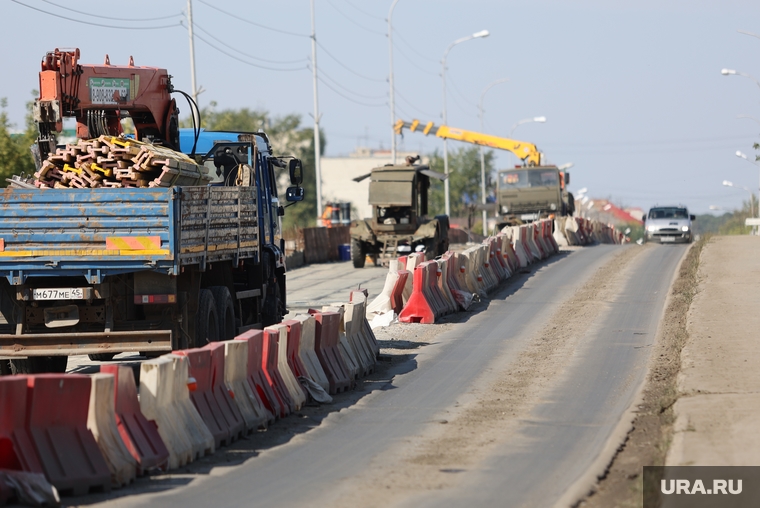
87,374,137,488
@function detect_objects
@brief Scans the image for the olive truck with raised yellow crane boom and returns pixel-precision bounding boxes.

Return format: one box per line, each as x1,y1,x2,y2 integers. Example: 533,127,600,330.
394,120,575,229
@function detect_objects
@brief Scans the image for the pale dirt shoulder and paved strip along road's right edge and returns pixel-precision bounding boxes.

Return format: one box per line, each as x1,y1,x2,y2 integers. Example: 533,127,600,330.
577,236,760,508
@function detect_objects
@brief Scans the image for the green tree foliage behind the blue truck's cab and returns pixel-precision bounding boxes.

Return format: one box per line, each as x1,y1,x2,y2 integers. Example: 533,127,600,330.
185,102,326,230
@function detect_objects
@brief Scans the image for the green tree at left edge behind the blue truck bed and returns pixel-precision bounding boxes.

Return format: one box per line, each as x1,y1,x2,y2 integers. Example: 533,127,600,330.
0,92,37,187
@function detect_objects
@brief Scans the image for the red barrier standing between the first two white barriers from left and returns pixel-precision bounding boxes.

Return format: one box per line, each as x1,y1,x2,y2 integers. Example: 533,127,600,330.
100,365,169,475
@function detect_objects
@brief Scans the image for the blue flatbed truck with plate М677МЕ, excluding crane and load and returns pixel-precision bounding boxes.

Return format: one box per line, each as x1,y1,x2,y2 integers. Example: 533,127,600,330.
0,131,304,373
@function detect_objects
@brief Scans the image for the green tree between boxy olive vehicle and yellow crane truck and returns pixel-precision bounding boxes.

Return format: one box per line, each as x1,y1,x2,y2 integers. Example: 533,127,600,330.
430,147,494,220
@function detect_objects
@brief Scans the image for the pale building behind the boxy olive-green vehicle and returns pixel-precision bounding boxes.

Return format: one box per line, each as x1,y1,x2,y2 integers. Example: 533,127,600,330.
321,148,429,219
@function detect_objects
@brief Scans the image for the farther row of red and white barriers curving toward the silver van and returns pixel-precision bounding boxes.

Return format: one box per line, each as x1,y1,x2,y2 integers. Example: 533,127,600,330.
367,217,627,324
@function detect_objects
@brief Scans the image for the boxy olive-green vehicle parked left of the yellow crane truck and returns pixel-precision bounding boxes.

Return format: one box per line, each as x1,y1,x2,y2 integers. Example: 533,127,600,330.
351,156,449,268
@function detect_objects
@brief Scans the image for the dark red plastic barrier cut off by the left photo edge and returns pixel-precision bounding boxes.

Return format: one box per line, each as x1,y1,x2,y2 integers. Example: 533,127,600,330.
0,376,43,473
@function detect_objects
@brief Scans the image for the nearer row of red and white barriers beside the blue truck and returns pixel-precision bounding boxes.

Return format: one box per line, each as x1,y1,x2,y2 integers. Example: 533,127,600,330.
0,291,379,505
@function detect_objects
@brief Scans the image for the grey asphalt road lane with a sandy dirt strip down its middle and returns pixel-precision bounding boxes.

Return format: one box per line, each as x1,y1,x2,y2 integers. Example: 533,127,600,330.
81,245,686,508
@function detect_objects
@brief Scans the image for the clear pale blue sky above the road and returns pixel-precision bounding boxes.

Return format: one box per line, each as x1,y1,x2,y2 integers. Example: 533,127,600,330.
0,0,760,213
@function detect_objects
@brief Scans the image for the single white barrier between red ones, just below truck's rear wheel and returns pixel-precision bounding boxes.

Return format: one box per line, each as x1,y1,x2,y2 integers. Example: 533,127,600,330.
224,340,270,432
